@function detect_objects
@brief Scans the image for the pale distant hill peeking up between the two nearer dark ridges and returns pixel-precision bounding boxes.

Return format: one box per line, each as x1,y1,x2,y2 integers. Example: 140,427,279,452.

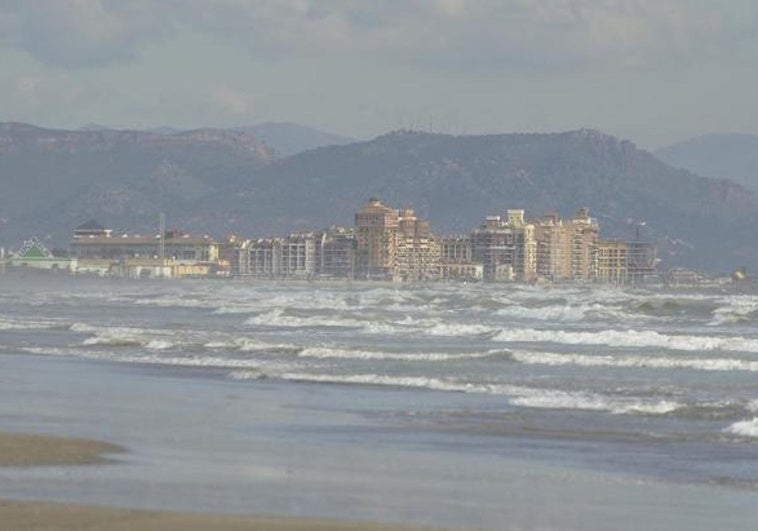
234,122,355,157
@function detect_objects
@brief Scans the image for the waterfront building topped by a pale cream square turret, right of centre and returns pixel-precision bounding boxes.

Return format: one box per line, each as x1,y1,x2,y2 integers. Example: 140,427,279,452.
471,209,537,282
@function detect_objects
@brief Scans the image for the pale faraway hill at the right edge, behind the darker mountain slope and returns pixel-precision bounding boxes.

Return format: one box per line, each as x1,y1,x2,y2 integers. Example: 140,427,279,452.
655,134,758,190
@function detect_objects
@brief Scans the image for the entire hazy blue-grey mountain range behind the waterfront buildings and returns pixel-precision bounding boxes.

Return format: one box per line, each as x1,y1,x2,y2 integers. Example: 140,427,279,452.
0,123,758,271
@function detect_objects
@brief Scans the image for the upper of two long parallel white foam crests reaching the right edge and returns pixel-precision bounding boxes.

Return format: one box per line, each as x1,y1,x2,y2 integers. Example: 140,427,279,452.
492,328,758,352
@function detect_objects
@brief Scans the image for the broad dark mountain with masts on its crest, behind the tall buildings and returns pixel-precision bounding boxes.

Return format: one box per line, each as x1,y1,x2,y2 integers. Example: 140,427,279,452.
218,130,758,269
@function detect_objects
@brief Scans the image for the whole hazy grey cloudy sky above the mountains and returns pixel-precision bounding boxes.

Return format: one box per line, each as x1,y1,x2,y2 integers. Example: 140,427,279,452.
0,0,758,148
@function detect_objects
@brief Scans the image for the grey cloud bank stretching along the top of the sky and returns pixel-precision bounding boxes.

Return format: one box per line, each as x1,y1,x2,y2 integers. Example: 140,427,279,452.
0,0,758,71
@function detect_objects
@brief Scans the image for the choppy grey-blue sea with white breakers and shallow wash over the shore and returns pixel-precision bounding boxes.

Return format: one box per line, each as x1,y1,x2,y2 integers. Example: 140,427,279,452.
0,273,758,530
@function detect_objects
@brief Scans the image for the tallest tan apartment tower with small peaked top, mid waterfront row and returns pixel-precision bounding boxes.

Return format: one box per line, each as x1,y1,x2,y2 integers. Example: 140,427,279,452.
355,198,400,279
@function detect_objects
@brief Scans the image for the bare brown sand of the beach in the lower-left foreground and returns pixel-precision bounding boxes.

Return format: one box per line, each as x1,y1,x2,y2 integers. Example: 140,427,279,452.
0,432,440,531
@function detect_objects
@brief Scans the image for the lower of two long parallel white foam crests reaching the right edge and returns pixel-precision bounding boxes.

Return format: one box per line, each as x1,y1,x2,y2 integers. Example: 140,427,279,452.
512,351,758,372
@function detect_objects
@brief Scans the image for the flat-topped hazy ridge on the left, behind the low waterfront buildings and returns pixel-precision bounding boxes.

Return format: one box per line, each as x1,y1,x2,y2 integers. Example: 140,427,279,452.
0,123,273,246
